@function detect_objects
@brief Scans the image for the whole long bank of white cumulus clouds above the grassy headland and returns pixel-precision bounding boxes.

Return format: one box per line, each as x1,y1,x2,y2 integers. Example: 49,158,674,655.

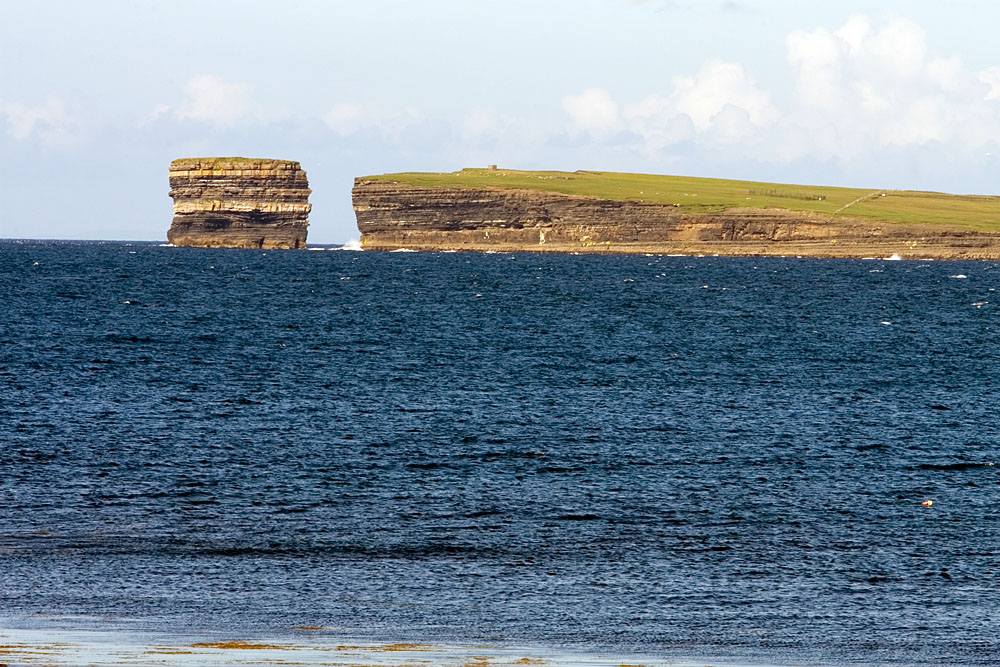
562,15,1000,168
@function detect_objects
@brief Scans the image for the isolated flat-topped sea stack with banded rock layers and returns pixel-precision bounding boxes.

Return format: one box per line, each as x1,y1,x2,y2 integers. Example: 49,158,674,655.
167,157,312,248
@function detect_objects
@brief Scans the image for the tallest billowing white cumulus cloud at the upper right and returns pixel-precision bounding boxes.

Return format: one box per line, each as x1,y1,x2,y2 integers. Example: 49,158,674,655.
783,16,1000,160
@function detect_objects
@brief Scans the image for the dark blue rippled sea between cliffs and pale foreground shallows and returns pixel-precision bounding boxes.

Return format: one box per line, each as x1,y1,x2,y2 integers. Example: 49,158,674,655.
0,241,1000,666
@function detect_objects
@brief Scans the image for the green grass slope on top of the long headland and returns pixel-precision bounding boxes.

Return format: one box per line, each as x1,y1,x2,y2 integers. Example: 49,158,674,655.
365,169,1000,231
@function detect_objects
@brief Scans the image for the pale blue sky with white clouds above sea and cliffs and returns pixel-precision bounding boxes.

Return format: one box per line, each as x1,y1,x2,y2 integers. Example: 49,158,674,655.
0,0,1000,243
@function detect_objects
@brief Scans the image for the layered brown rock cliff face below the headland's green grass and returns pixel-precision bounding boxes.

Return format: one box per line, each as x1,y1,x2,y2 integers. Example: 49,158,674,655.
352,178,1000,259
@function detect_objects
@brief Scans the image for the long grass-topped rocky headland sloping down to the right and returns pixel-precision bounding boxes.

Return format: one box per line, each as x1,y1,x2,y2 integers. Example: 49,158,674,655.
353,167,1000,260
